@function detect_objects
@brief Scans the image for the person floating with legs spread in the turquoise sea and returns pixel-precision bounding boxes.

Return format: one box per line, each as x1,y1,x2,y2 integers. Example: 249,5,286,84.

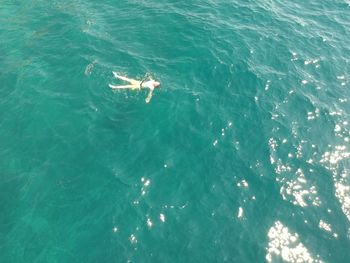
109,71,160,103
